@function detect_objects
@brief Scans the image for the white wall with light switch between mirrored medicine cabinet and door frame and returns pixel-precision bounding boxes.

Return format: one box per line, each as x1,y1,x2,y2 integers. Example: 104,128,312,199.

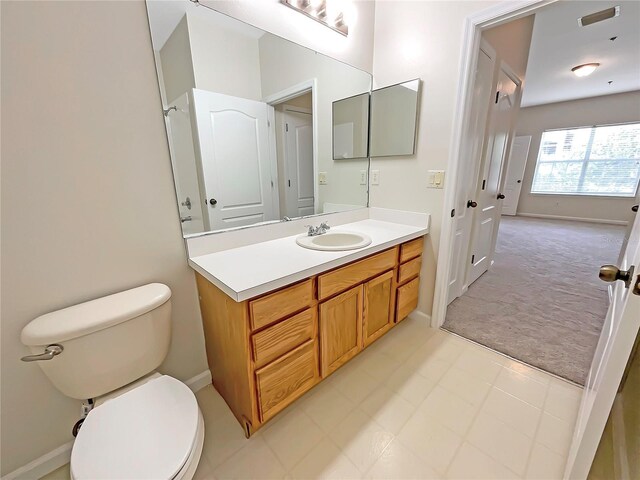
370,1,499,314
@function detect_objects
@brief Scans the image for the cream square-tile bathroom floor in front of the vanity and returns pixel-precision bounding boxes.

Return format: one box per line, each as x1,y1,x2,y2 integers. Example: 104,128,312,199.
38,319,581,480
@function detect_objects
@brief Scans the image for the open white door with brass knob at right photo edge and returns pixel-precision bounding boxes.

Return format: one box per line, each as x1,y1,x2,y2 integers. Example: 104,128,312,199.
565,208,640,479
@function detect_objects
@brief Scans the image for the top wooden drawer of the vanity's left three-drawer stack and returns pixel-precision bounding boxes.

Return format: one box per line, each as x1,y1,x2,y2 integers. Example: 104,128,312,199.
249,278,313,330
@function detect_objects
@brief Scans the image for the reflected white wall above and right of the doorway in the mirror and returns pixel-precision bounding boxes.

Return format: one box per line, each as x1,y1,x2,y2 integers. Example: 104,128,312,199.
259,34,371,212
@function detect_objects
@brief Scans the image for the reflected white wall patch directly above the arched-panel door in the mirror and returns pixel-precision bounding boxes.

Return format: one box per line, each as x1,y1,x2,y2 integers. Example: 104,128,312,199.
187,9,262,100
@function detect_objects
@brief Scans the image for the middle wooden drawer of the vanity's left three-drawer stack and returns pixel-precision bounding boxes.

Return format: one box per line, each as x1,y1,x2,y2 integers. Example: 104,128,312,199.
251,308,317,368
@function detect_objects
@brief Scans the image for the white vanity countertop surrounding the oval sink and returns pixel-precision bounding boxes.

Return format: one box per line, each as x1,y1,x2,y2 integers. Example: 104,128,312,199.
189,216,429,302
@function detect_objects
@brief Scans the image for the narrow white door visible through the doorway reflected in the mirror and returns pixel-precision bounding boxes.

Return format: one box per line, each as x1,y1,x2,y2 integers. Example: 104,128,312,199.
283,109,315,217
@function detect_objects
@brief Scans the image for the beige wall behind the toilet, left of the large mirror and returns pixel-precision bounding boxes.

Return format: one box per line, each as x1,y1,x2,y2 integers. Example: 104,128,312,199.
0,1,207,475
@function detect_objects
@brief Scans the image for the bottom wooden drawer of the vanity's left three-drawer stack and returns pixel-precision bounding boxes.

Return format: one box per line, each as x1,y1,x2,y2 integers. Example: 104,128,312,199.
256,340,319,422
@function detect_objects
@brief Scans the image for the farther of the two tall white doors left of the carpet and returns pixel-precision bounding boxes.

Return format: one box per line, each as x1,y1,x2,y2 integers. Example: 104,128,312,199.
466,66,520,285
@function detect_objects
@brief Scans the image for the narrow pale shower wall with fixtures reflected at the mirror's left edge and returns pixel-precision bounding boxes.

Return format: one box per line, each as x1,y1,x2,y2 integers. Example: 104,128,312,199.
165,93,209,235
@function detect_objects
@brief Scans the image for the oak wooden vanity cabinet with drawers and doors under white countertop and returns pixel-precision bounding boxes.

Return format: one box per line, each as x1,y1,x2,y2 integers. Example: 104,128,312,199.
196,237,424,437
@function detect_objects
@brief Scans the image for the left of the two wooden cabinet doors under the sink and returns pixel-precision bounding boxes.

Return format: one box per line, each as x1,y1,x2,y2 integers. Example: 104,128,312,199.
320,285,363,378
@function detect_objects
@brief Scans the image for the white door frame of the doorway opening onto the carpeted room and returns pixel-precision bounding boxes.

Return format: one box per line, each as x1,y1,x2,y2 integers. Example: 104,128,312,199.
431,0,557,328
